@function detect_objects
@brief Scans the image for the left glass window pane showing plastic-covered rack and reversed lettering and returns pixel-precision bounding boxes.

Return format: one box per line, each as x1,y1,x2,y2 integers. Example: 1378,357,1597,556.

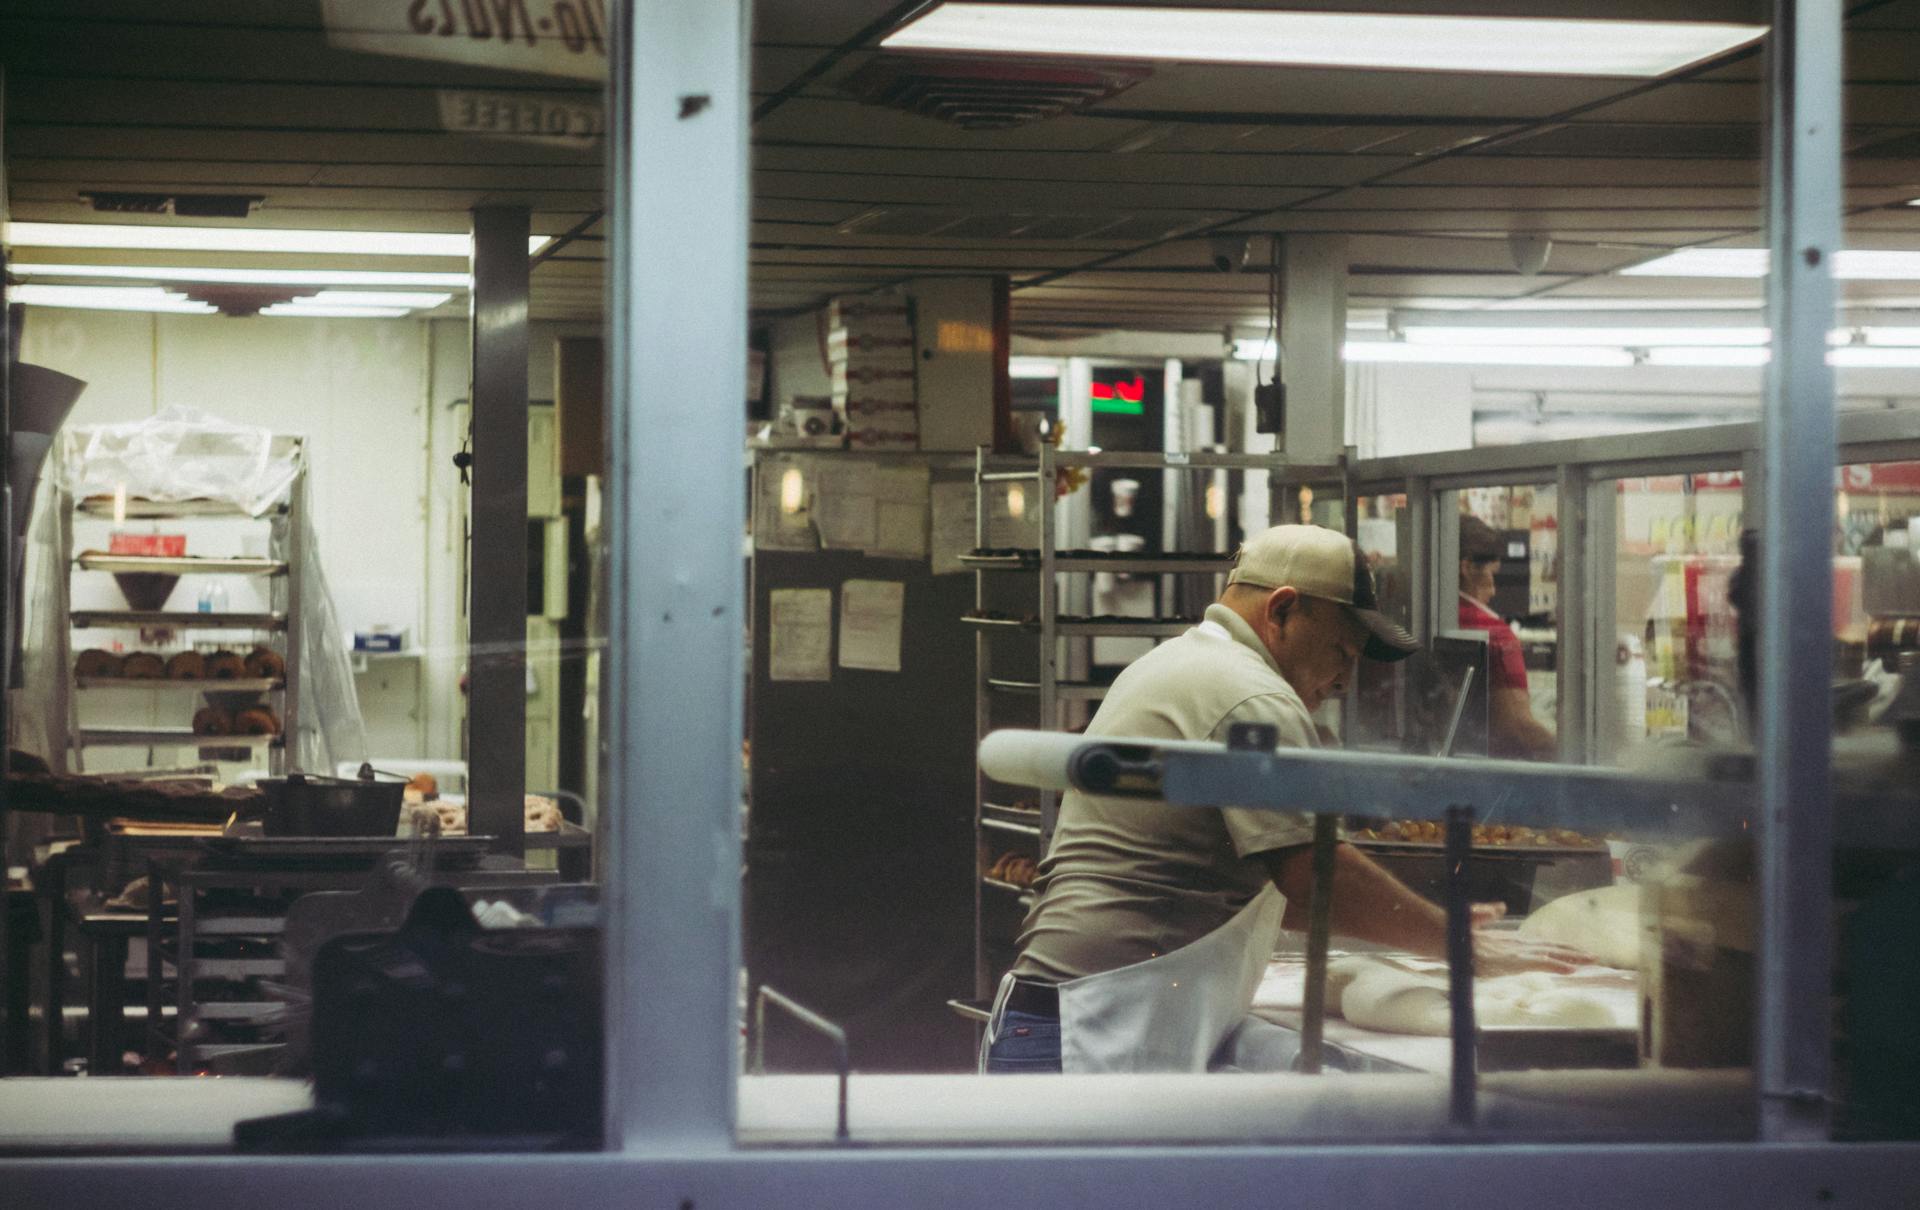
0,4,610,1152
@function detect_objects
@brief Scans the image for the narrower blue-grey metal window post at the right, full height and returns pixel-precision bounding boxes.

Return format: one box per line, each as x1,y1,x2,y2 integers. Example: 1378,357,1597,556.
1755,0,1841,1141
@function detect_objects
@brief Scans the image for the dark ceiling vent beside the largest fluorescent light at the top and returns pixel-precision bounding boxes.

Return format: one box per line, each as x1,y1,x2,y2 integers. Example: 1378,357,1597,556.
841,54,1152,131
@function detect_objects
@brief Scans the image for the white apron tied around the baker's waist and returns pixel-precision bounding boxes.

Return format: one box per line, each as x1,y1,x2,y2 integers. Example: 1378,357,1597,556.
981,883,1286,1074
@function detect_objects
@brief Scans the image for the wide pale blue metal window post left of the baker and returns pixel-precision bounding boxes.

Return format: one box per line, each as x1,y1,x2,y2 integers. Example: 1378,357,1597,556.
605,0,747,1156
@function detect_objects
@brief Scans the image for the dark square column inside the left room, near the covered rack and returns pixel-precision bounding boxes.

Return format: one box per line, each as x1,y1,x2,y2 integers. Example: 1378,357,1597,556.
467,206,530,857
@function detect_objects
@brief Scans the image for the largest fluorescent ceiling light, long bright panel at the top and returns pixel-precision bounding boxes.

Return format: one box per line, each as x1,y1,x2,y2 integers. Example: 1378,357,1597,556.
879,2,1766,77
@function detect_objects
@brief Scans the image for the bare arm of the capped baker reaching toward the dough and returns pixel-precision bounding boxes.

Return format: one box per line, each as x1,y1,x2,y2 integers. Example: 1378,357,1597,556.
1260,845,1594,974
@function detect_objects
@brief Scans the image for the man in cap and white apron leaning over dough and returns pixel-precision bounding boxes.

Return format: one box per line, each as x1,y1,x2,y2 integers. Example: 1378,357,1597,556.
985,524,1584,1072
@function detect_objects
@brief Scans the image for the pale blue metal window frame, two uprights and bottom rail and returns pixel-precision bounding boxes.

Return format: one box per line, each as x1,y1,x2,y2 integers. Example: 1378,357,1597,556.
0,0,1920,1210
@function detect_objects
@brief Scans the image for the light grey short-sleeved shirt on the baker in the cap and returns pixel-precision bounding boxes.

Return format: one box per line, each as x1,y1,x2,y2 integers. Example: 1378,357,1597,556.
1014,605,1317,983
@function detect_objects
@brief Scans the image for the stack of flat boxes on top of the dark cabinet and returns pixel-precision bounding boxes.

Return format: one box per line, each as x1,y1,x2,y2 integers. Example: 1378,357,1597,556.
828,294,920,449
